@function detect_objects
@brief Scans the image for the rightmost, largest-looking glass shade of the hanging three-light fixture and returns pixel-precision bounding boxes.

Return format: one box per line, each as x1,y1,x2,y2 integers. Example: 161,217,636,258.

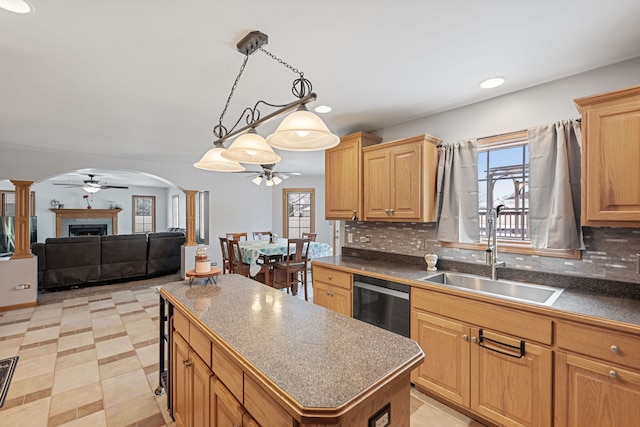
267,105,340,151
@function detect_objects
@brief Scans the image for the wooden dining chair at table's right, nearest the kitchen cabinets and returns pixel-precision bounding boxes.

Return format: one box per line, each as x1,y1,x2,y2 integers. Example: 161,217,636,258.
271,239,311,301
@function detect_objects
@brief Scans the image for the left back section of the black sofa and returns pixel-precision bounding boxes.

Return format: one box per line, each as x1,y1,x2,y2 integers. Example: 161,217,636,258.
44,236,100,289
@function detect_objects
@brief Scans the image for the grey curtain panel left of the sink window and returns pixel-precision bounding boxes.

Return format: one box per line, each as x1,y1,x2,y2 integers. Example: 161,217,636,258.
436,139,480,243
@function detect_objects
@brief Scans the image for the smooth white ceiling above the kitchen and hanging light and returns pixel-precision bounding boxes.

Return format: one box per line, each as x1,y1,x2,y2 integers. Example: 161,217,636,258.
0,0,640,184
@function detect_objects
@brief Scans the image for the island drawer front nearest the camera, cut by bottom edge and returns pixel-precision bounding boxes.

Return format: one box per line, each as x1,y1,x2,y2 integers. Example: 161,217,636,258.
244,377,294,427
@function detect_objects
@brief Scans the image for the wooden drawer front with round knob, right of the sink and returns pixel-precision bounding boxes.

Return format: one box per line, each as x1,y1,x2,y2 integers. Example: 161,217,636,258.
556,322,640,367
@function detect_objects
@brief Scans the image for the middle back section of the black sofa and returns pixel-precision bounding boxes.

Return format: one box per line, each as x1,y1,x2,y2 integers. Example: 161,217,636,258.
100,234,147,282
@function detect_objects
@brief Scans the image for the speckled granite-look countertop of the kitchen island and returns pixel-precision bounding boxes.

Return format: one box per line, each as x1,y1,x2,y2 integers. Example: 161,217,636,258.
161,274,424,408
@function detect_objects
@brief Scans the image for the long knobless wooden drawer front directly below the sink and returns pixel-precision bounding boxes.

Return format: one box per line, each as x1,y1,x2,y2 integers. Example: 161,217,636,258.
411,287,553,345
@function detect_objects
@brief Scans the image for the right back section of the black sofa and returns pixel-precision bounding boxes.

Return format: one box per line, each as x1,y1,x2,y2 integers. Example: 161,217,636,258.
147,231,185,276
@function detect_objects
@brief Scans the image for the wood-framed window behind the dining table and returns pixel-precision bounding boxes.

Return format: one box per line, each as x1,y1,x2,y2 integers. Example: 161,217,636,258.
282,188,315,239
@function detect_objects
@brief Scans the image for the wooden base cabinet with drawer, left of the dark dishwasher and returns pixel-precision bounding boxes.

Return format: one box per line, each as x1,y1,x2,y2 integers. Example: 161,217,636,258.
312,265,353,317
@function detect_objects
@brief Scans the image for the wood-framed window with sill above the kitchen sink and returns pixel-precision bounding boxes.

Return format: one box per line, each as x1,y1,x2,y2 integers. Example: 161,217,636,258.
441,131,581,259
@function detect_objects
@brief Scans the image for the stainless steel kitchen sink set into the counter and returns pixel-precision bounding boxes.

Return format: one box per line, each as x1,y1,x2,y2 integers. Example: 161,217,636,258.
423,273,564,306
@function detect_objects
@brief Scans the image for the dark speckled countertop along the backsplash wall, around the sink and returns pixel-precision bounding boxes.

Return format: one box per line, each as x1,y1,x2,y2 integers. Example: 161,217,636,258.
313,255,640,326
